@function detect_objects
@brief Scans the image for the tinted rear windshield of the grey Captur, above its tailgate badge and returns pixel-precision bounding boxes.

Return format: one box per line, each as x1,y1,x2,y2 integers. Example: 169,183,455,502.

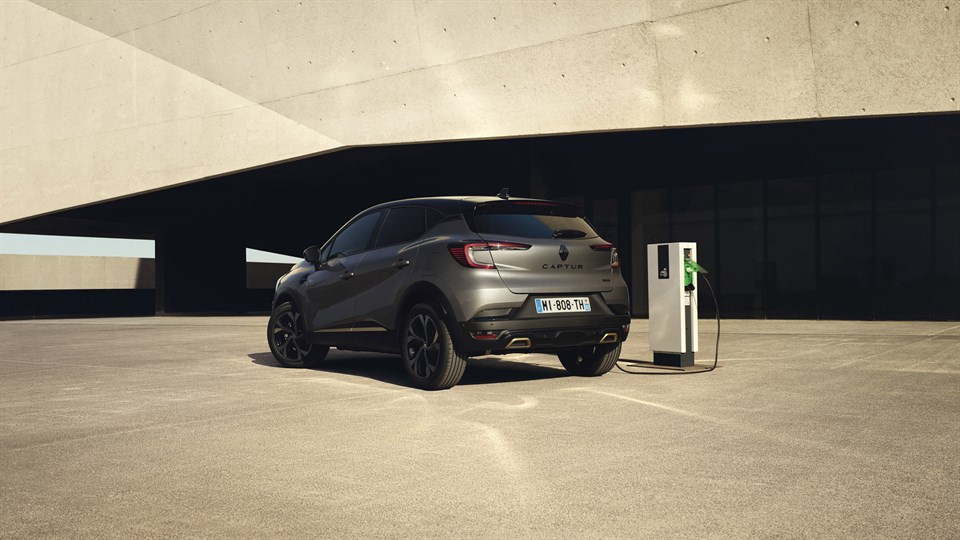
473,201,597,239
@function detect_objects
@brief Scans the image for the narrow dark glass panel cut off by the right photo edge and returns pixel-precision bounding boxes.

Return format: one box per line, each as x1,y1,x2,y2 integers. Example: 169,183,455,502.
933,166,960,321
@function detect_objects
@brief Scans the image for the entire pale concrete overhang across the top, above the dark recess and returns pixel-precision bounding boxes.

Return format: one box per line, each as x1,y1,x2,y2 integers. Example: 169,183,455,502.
0,0,960,223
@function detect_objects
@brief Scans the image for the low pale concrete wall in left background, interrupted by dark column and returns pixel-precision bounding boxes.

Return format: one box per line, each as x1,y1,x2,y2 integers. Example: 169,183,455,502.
0,254,290,291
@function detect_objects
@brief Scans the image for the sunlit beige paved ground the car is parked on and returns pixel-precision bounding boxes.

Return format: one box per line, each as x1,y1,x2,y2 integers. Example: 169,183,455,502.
0,317,960,538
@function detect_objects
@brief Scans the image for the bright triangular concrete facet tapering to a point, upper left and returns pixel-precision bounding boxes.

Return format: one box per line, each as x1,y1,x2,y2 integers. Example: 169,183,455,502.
0,0,340,222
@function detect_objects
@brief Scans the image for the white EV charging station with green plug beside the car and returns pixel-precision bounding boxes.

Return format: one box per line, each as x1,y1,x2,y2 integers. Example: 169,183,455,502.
647,242,706,367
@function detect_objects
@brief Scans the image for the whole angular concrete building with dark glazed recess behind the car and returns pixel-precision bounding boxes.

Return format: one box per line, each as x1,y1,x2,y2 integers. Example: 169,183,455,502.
0,0,960,319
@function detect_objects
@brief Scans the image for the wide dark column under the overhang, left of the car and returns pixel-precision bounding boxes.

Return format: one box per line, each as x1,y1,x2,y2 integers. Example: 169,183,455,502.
156,227,248,315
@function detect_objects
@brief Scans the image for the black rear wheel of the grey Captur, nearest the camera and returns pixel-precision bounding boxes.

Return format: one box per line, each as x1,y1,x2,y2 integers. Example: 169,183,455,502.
400,304,467,390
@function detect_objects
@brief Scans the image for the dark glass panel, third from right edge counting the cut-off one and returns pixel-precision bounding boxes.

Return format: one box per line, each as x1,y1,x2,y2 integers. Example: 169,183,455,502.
819,173,874,319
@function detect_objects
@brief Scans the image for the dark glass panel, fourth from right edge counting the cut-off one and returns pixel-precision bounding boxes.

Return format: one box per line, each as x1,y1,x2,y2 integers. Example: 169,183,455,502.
766,178,817,319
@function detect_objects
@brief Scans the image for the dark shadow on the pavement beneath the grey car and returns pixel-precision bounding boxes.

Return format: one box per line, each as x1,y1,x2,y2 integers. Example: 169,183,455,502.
247,350,570,387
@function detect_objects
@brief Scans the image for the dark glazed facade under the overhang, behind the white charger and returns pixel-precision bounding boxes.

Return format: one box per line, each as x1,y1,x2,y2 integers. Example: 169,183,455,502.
586,166,960,320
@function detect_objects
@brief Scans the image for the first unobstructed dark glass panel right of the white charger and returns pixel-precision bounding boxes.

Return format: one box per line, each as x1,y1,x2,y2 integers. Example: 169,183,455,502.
720,181,763,318
